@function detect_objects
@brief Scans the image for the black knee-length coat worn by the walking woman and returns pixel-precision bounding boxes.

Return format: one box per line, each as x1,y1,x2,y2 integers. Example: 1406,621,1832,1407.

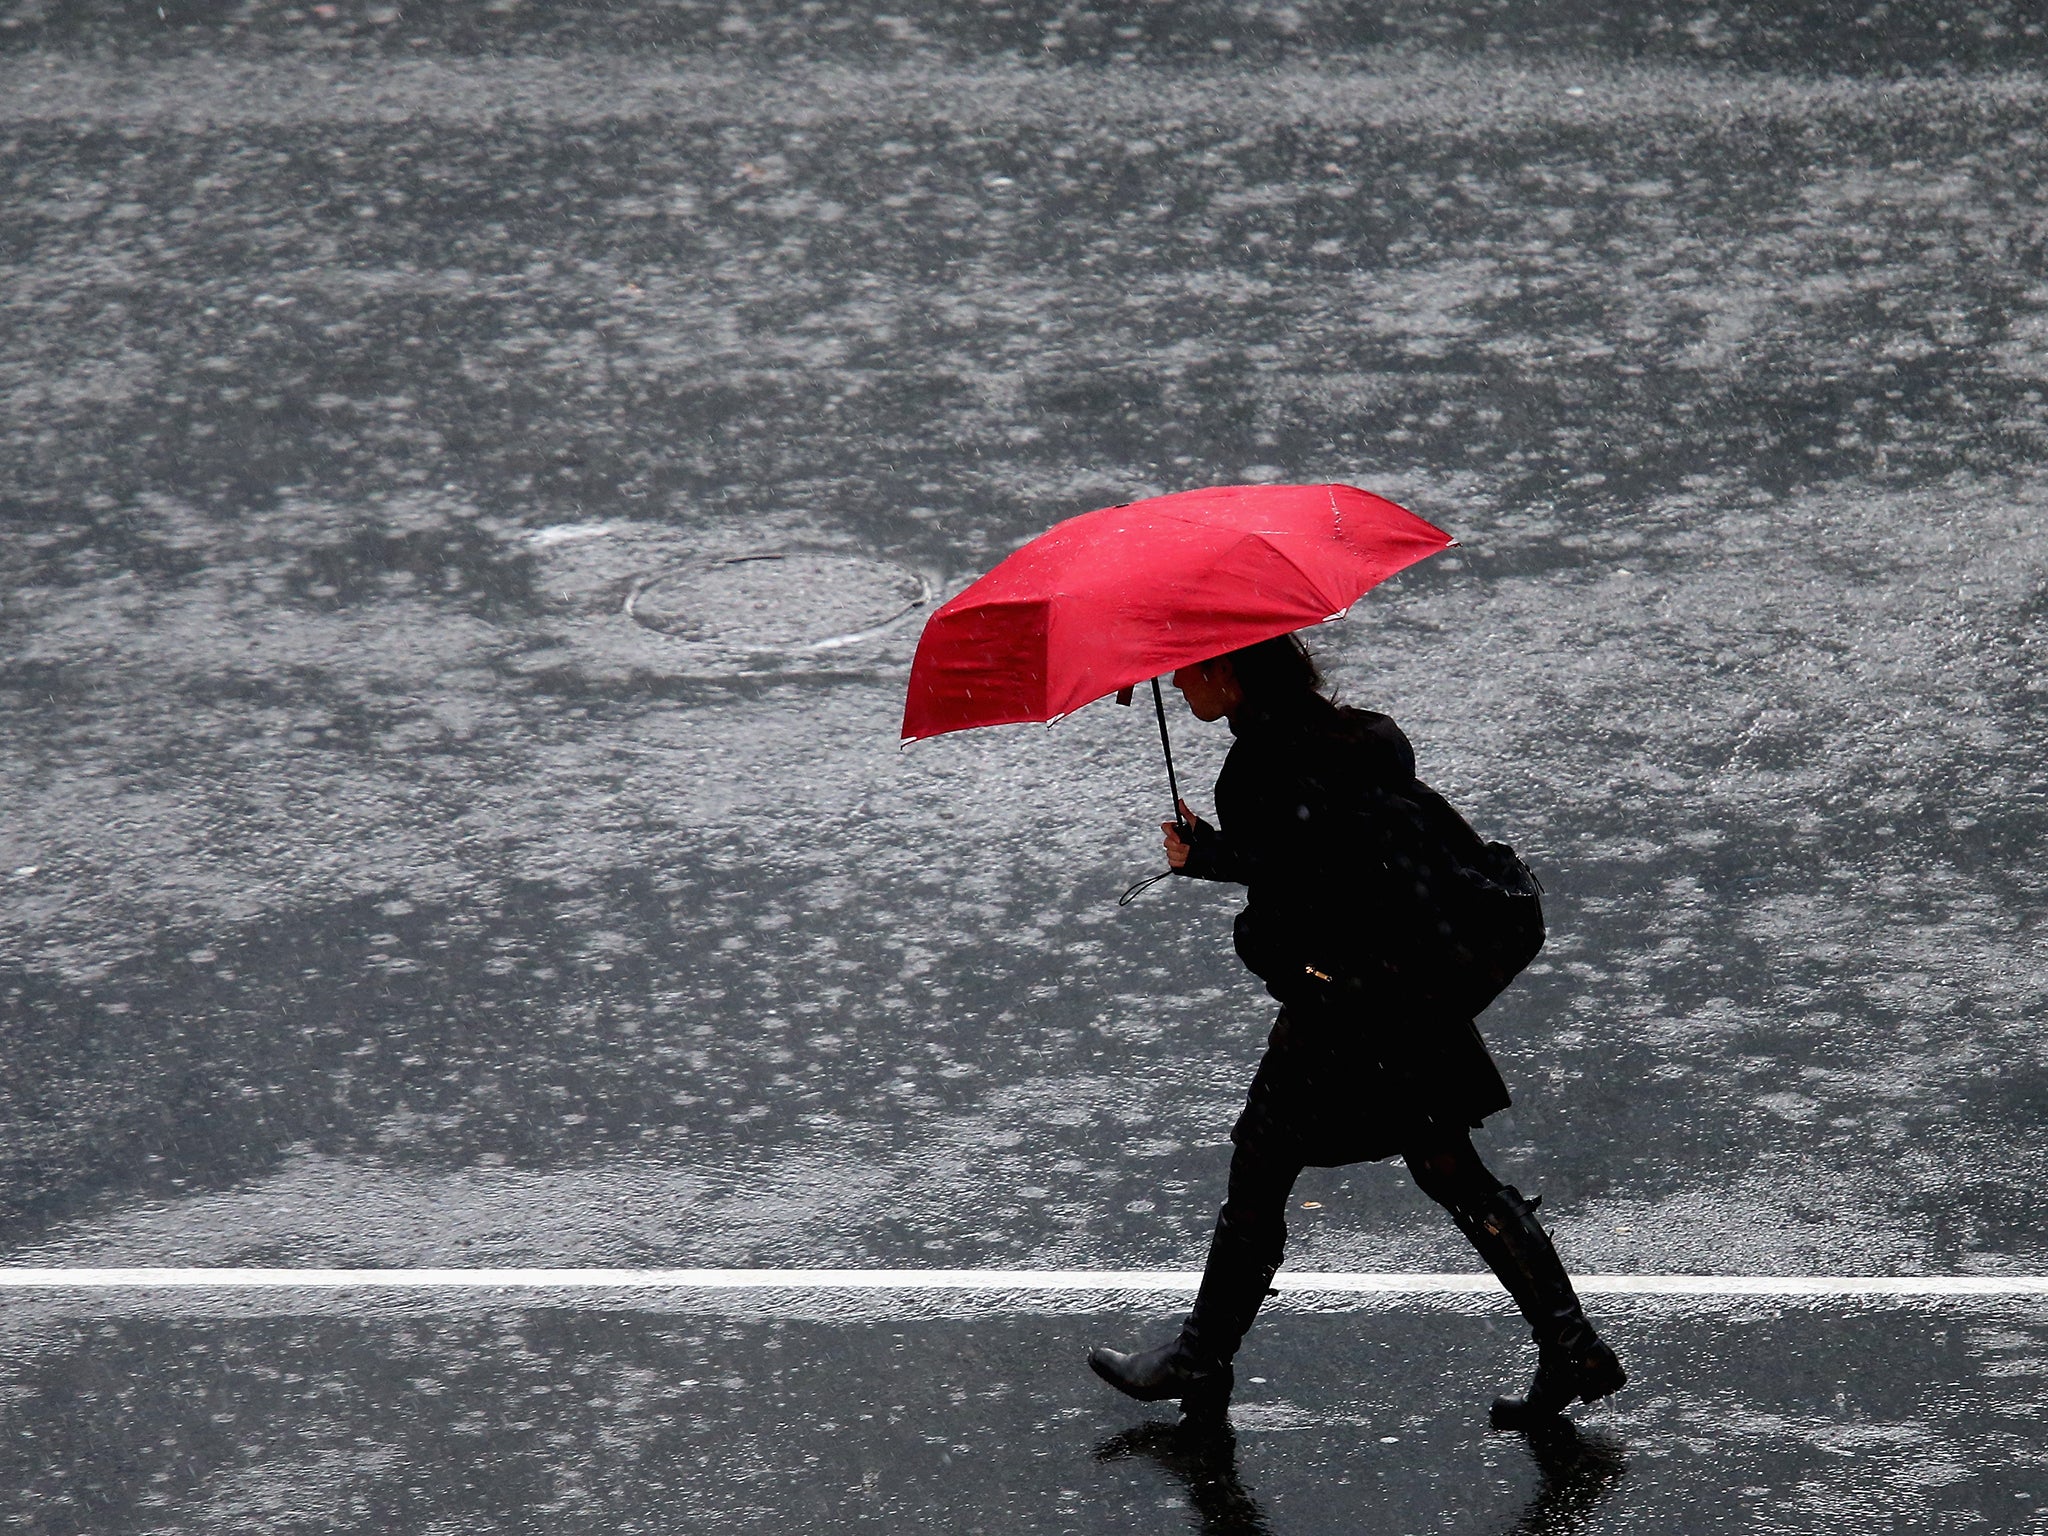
1182,694,1509,1167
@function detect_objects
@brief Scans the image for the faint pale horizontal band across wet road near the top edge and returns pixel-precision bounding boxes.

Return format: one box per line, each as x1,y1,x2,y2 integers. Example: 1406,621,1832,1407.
0,53,2044,133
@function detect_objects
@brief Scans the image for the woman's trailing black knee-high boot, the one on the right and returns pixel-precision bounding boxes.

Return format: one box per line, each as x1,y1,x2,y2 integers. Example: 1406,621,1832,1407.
1452,1184,1628,1430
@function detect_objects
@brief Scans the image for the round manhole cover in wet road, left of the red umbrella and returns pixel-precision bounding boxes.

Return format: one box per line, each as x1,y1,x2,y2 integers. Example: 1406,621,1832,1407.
627,551,932,651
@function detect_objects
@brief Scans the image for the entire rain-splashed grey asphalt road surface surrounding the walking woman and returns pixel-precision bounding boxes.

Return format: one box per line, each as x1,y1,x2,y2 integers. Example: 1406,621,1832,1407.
0,0,2048,1530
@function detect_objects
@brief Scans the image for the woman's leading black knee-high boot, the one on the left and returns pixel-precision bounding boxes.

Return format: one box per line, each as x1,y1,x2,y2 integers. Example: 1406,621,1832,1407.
1087,1204,1286,1427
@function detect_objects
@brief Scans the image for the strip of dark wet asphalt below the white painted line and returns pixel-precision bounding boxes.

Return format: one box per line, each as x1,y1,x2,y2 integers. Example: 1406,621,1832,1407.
8,1303,2048,1536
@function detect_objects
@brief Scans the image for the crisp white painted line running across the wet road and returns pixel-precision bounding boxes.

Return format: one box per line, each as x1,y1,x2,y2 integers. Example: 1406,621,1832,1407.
0,1268,2048,1296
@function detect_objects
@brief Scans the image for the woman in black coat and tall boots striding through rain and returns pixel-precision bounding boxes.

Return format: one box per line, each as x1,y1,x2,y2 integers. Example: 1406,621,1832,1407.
1087,635,1628,1427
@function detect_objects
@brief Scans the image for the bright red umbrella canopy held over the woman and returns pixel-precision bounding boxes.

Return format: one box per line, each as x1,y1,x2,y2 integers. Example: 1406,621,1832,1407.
903,485,1454,741
